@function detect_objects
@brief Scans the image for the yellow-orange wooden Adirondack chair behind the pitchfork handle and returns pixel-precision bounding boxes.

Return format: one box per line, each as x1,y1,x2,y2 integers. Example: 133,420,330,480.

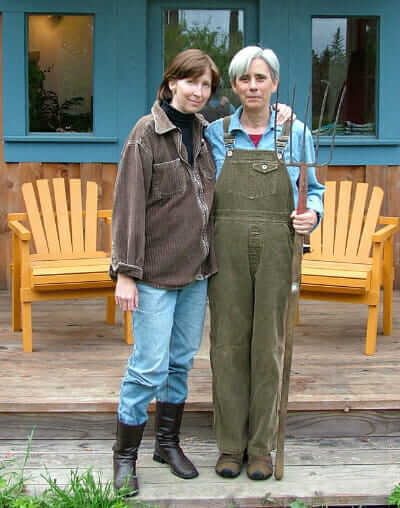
300,181,399,355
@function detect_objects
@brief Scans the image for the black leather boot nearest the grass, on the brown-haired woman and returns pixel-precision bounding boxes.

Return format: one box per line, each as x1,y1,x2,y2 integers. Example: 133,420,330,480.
113,420,146,497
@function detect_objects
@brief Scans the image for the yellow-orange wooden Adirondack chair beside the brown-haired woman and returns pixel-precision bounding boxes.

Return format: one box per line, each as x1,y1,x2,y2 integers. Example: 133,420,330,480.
8,178,132,352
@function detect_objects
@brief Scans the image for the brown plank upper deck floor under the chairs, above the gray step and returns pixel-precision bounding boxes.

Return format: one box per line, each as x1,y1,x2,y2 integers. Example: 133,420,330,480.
0,291,400,413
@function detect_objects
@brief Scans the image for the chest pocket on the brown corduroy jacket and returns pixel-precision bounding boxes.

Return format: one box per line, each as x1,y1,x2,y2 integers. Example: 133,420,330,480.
152,159,186,198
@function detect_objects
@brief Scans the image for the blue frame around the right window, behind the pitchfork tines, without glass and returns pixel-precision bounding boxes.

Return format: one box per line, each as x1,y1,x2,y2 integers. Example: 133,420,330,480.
289,0,400,155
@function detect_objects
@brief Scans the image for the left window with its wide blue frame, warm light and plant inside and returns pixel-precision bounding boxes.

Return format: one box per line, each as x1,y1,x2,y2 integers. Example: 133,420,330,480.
0,0,117,162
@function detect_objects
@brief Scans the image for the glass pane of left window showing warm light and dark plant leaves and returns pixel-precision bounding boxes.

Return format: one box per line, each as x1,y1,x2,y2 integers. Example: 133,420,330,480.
28,14,93,132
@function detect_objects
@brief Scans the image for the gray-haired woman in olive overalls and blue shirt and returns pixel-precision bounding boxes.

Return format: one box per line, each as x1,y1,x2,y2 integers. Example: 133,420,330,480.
206,46,324,480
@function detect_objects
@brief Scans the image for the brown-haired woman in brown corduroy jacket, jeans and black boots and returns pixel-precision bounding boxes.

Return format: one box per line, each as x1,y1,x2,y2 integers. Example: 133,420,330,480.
110,49,219,495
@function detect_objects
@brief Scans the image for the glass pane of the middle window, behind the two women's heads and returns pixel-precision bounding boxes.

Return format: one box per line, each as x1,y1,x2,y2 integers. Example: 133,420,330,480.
164,9,244,121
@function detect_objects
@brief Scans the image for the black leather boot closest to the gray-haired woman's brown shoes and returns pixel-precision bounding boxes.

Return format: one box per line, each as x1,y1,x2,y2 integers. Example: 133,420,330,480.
153,402,199,479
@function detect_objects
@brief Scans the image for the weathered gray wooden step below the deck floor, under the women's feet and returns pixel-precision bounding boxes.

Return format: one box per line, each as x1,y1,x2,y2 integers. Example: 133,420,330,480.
0,413,400,508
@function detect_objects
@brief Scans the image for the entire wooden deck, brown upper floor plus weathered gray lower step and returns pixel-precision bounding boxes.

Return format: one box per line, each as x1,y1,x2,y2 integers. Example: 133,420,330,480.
0,292,400,508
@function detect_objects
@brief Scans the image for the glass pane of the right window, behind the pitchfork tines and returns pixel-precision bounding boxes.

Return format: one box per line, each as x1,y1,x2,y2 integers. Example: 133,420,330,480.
312,17,378,136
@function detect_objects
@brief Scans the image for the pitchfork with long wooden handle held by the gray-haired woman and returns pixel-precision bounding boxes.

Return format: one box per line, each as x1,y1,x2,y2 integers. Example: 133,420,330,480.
274,83,346,480
